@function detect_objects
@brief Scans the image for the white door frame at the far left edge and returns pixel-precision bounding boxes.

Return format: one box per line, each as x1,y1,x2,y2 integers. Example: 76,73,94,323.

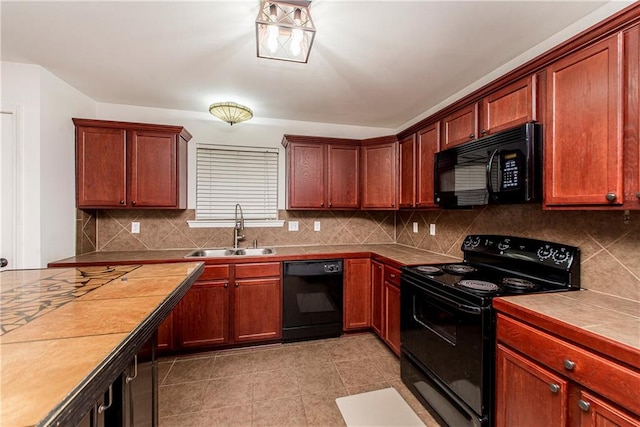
0,105,24,270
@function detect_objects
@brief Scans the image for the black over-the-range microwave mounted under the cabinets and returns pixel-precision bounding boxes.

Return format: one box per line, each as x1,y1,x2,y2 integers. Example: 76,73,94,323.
434,122,542,208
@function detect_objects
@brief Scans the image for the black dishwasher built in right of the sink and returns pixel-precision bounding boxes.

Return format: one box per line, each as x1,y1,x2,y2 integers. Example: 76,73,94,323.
282,259,343,342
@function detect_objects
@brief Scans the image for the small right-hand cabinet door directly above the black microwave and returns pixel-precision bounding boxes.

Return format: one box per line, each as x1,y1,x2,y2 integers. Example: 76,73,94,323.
480,75,537,137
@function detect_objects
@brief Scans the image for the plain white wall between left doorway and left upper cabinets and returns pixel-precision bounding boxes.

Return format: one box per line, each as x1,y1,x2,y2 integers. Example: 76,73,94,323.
1,62,95,268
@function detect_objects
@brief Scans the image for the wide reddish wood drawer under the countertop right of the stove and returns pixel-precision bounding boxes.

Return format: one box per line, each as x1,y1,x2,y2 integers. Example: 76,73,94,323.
497,314,640,414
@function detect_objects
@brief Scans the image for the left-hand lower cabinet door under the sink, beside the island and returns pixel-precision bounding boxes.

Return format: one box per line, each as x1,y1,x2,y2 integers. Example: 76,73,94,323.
178,280,229,348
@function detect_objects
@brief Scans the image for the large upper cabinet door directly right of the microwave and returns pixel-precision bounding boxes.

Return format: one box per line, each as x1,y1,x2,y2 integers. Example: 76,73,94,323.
544,34,623,206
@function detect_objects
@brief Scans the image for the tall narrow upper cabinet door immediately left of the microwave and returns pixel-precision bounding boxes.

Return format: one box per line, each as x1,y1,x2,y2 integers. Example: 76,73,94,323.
415,121,440,208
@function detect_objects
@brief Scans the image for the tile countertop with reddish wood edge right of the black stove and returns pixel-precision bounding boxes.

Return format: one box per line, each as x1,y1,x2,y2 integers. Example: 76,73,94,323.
493,290,640,369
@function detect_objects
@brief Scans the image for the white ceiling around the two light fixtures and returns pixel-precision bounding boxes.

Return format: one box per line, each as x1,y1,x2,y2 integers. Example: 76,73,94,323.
1,0,620,128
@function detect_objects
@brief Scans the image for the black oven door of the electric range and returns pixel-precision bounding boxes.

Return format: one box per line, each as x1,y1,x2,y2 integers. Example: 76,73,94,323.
401,274,494,422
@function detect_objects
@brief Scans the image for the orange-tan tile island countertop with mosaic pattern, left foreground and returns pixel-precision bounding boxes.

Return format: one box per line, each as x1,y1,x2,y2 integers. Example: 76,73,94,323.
0,262,204,426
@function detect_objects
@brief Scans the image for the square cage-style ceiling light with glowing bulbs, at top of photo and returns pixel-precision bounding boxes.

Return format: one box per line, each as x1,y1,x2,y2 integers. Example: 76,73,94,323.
256,0,316,63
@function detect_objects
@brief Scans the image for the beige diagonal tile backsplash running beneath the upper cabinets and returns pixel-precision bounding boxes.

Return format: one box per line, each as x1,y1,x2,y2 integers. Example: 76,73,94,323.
76,204,640,301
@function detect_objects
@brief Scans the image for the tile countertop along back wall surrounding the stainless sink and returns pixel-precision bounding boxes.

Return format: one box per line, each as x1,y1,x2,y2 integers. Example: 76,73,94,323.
49,243,460,267
